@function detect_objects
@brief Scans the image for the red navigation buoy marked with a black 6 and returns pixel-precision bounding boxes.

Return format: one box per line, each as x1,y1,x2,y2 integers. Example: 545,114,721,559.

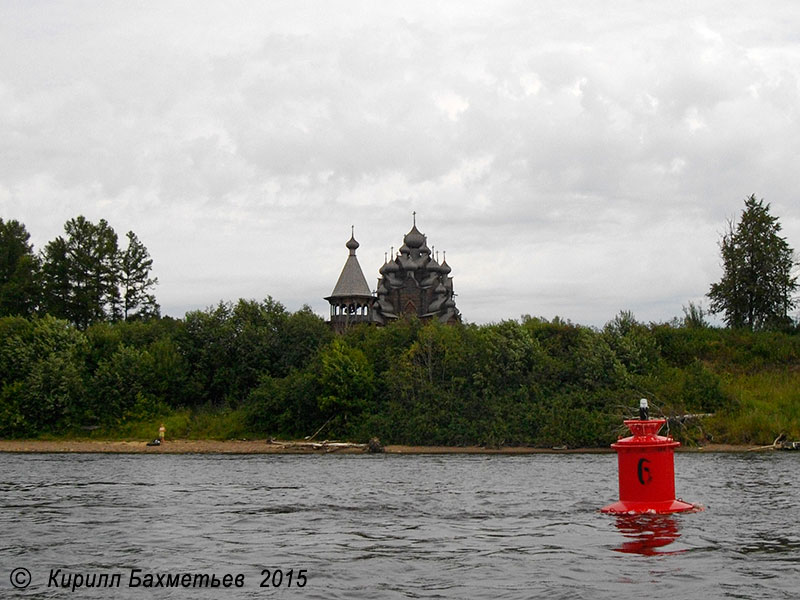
600,399,702,515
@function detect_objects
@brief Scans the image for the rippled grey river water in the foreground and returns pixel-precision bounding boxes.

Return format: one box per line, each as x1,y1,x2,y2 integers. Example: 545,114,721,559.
0,452,800,600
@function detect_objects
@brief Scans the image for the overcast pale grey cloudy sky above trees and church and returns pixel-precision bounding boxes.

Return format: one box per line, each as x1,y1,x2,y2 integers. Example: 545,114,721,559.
0,0,800,326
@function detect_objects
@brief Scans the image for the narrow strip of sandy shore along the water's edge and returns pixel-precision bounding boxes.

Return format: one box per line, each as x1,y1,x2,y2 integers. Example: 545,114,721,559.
0,440,750,455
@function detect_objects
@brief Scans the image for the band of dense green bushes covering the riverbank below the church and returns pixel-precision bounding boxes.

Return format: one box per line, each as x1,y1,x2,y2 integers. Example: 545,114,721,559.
0,298,800,446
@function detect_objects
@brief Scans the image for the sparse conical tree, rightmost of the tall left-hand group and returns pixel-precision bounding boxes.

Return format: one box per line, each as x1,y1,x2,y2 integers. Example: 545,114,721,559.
119,231,160,321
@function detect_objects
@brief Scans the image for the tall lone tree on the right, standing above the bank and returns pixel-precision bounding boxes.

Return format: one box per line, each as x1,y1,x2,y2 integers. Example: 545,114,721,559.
707,195,797,330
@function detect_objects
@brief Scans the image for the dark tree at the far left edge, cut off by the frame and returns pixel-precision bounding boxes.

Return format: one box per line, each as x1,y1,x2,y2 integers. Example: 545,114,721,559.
0,218,39,316
